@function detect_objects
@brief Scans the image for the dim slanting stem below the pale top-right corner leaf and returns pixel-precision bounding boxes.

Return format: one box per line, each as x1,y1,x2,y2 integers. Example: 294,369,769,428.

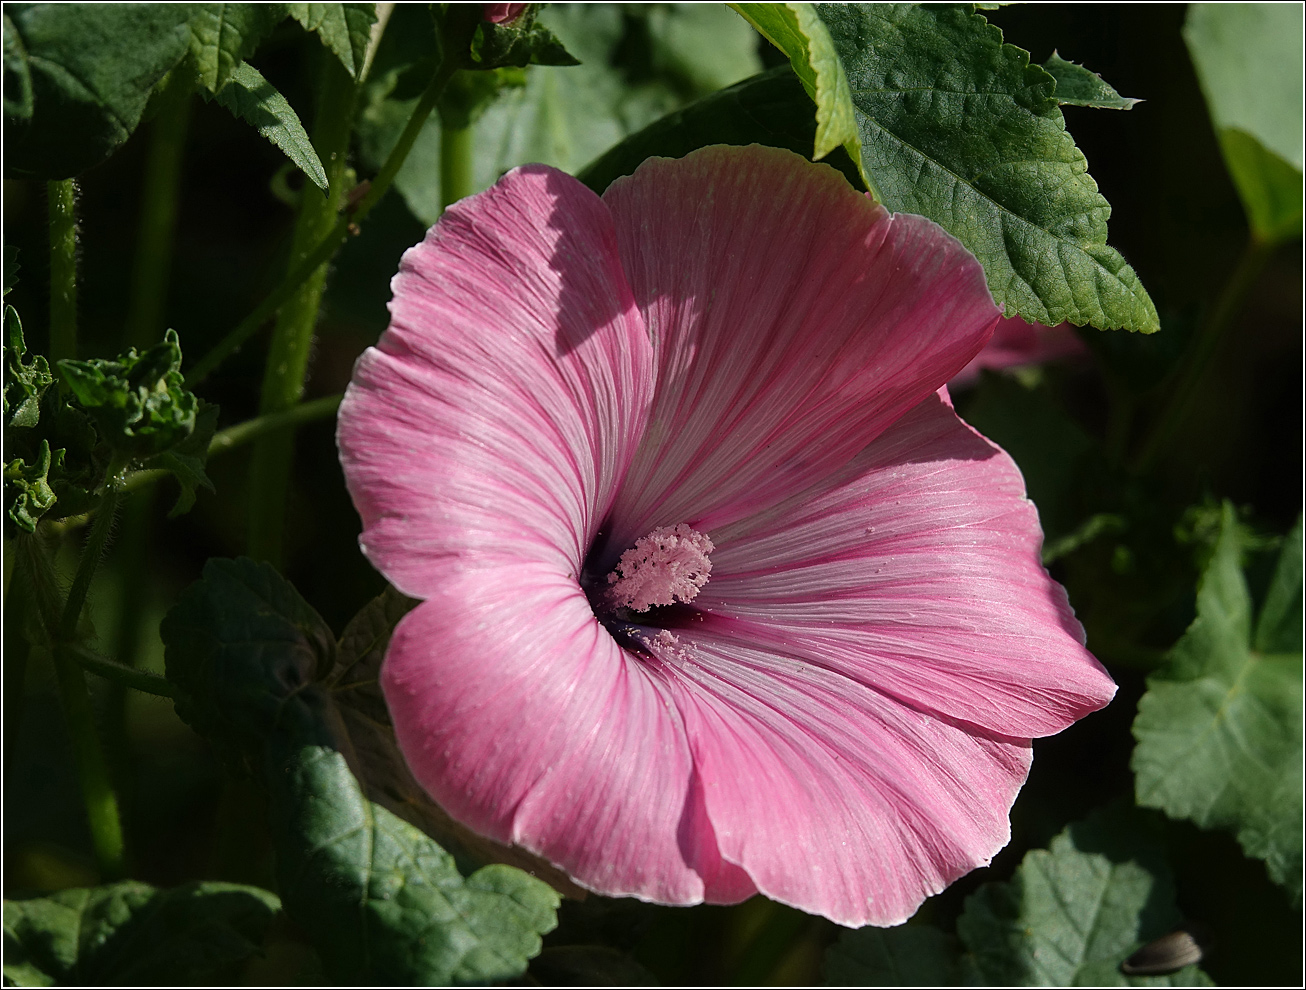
1134,234,1275,474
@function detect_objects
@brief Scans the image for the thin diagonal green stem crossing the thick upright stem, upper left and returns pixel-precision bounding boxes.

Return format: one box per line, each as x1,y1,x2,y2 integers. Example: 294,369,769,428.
185,57,453,388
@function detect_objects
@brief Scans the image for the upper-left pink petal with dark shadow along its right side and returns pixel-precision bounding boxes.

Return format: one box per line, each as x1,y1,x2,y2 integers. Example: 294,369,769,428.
338,166,653,598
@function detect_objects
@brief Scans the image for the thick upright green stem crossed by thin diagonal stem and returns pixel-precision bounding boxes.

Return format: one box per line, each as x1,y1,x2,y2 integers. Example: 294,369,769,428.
248,56,357,567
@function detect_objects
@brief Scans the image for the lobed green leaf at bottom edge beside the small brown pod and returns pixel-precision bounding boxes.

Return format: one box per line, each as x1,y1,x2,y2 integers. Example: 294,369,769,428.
957,807,1213,986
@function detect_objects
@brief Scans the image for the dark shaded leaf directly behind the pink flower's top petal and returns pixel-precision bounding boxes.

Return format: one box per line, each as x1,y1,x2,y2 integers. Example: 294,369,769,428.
577,65,861,193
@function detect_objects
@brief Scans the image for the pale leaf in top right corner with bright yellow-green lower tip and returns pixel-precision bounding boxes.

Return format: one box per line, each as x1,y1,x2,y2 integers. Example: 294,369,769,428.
1183,4,1302,242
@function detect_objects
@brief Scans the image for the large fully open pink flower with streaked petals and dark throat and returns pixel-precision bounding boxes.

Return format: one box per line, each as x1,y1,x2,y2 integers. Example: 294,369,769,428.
340,146,1115,925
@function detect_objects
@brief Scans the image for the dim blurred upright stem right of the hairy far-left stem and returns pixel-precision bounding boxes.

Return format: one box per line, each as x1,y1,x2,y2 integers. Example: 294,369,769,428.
127,71,192,349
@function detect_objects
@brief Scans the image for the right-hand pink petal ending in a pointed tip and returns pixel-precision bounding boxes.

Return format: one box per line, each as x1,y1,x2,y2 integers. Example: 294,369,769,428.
693,396,1115,738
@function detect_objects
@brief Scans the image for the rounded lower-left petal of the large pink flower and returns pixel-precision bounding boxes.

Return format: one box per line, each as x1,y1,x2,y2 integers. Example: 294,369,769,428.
381,564,755,904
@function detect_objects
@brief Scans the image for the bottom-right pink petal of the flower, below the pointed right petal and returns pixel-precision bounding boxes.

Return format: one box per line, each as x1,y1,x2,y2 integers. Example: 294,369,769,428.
637,627,1030,927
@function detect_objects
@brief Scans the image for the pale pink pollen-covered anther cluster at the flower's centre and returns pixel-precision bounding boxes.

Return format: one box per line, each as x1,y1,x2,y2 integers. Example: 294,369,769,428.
607,522,716,611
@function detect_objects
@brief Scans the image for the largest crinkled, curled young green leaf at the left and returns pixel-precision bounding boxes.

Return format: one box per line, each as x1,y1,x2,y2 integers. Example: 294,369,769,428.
59,330,199,458
